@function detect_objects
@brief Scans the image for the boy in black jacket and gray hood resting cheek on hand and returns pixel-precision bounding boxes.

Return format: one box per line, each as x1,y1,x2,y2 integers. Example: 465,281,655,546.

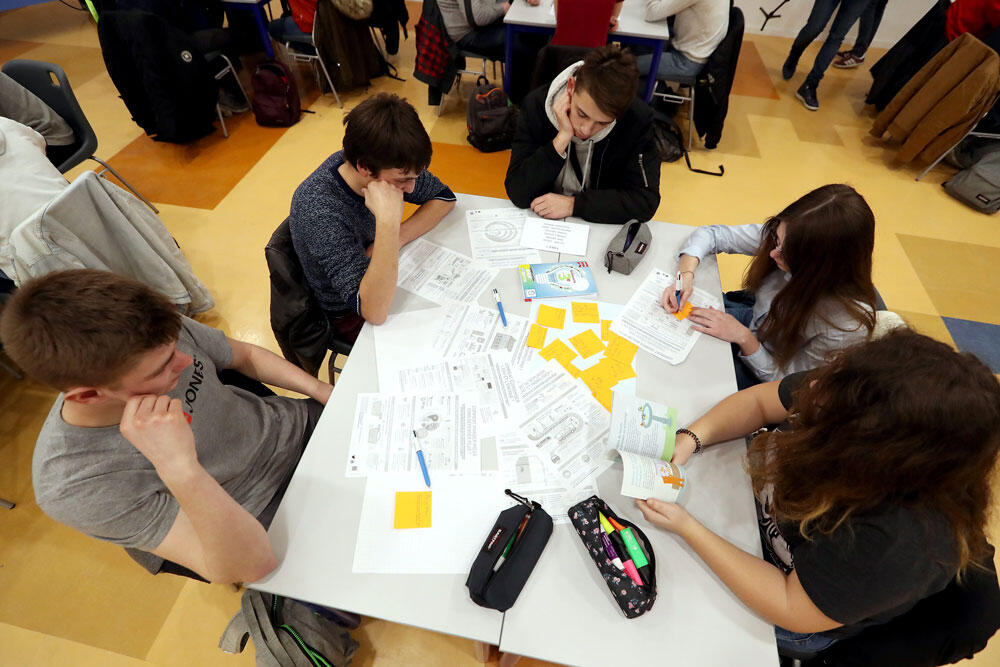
505,46,660,224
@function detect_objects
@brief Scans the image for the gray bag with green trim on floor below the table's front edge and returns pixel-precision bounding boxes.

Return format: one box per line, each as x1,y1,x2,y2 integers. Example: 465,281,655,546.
219,589,358,667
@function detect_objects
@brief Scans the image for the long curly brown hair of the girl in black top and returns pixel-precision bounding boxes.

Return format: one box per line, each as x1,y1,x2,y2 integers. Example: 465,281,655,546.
748,328,1000,572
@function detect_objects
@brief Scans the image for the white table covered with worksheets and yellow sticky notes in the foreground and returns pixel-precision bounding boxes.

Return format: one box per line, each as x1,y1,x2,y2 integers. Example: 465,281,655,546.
246,195,777,665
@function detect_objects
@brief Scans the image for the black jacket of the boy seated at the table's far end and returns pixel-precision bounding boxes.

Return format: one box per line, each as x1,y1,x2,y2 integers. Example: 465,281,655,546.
504,86,660,224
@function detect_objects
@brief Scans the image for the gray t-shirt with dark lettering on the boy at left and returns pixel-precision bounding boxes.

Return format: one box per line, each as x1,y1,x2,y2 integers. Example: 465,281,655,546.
32,318,308,551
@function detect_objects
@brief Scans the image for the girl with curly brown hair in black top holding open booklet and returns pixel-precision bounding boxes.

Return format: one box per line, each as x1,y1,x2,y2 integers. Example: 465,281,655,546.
636,328,1000,664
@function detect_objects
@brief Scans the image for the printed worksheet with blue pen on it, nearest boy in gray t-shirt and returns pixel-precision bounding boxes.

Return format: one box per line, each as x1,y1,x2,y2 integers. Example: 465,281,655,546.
346,393,481,480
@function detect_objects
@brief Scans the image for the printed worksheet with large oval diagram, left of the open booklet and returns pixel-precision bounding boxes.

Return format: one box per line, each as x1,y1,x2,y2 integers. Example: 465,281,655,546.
518,360,611,489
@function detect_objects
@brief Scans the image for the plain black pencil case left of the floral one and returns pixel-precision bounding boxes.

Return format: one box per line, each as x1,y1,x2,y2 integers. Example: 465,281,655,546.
465,489,552,611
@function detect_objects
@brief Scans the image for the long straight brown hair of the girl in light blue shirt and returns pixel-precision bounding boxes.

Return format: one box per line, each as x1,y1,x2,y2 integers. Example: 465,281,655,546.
743,184,875,367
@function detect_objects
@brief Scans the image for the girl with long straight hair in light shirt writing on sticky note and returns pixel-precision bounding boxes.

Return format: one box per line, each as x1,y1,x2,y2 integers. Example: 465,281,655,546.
662,184,876,389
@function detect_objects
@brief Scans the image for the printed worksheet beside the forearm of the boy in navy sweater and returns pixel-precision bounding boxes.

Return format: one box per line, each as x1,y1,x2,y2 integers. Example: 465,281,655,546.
396,239,496,304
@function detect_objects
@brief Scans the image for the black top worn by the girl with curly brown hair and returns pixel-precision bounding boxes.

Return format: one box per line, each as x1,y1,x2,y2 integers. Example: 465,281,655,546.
757,373,957,638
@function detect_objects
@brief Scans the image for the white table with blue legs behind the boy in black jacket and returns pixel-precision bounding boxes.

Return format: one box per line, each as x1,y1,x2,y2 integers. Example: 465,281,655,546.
503,0,670,102
